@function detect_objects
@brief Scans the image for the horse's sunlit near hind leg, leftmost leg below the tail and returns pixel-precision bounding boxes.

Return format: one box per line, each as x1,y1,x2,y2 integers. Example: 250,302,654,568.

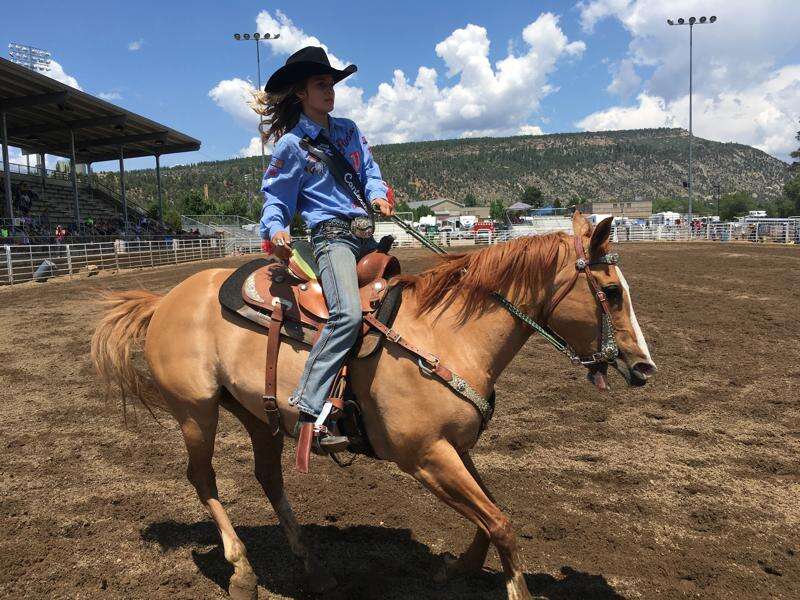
177,401,258,600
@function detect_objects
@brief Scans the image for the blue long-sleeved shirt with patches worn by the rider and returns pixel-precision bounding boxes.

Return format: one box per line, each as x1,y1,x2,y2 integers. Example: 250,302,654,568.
260,113,387,239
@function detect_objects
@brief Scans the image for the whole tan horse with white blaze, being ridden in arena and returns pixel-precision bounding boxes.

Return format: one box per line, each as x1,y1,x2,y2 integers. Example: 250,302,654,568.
92,213,655,599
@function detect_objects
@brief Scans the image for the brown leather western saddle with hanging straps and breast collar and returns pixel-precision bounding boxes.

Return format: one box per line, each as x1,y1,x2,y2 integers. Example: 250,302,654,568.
219,236,494,473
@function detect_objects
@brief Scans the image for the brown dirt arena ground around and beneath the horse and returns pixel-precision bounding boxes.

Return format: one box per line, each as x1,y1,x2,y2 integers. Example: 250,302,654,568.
0,243,800,600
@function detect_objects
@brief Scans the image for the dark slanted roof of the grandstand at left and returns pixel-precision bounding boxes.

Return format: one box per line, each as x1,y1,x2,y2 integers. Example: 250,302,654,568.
0,58,200,163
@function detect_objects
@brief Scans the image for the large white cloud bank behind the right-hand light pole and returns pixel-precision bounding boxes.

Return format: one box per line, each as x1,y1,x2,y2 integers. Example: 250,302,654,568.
576,0,800,159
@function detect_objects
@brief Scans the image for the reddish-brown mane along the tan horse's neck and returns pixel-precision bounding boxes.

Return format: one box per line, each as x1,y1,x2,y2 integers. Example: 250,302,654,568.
395,232,569,321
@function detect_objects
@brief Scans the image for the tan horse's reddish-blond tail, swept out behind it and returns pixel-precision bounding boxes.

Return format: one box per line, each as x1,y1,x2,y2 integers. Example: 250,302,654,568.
91,290,166,416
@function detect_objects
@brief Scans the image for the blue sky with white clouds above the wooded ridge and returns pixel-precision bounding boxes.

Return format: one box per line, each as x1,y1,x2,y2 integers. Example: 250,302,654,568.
0,0,800,169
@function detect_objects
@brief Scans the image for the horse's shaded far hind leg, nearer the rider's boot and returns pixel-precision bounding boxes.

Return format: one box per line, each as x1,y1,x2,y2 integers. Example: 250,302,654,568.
222,393,336,593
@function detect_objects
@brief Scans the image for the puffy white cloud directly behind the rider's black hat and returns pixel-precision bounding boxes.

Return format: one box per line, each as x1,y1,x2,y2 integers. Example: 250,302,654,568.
209,10,586,152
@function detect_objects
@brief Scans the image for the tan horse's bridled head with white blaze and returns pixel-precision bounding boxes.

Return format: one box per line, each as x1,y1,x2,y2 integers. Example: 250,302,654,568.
547,211,656,389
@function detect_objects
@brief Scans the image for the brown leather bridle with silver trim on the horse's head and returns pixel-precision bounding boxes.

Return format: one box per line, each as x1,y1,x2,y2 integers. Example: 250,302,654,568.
492,236,619,368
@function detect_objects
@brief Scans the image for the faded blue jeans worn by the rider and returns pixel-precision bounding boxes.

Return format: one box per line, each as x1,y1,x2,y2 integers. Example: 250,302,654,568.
289,223,377,417
